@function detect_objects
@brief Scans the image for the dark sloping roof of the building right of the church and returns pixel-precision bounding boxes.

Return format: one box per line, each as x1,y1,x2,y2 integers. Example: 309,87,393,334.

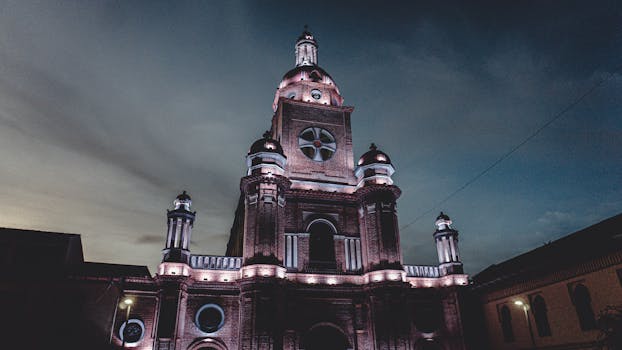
473,214,622,287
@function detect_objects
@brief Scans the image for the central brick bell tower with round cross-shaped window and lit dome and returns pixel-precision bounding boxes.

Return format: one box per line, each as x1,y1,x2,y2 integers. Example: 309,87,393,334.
271,28,356,192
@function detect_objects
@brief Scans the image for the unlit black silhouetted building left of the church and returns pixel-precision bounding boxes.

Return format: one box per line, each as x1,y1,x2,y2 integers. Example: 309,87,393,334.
0,228,152,349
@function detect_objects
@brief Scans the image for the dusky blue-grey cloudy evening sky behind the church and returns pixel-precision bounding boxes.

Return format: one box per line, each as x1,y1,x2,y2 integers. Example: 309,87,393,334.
0,1,622,273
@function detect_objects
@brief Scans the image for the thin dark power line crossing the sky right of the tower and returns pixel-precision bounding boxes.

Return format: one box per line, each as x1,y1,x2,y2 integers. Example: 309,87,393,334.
400,66,622,230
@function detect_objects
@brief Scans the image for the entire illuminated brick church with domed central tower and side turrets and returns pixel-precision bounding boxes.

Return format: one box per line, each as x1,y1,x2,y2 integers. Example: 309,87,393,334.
111,31,467,350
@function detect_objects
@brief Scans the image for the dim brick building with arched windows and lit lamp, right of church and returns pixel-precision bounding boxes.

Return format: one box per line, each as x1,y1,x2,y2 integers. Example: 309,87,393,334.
473,214,622,349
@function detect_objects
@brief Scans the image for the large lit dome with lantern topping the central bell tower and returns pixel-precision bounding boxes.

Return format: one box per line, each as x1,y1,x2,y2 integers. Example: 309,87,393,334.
272,30,343,111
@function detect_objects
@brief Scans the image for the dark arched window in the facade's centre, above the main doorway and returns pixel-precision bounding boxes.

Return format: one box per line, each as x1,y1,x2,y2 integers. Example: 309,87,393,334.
309,221,336,269
